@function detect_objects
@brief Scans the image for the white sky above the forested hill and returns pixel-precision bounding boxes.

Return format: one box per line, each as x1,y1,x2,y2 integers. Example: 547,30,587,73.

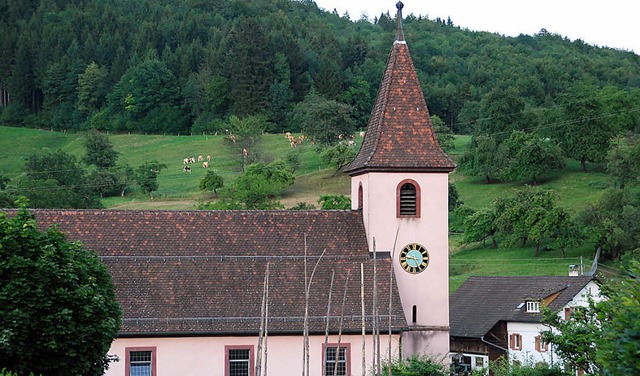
315,0,640,54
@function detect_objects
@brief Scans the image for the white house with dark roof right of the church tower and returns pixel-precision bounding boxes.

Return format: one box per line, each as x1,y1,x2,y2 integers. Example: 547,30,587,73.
450,276,600,370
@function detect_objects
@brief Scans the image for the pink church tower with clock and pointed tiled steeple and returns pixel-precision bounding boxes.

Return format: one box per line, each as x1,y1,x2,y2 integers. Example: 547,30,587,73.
345,2,456,358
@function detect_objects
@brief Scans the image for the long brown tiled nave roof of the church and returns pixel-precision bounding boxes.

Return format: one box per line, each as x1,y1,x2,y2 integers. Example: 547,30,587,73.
11,210,406,336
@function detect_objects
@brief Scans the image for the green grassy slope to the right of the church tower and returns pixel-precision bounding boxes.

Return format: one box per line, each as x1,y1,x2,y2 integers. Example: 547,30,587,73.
449,136,609,291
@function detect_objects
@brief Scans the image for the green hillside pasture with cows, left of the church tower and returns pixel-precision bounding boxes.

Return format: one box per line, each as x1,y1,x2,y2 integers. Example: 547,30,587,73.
0,127,342,210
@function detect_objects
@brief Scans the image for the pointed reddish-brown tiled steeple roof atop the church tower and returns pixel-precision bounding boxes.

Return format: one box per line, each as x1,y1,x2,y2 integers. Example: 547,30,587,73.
344,2,456,176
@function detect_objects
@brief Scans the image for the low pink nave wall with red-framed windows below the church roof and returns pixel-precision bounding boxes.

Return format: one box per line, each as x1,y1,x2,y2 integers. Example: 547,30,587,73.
105,334,400,376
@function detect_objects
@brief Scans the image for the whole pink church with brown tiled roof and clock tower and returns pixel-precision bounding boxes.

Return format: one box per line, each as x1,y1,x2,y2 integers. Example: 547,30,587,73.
23,2,455,376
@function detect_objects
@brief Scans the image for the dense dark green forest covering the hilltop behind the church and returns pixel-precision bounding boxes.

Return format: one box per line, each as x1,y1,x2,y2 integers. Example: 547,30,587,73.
0,0,640,135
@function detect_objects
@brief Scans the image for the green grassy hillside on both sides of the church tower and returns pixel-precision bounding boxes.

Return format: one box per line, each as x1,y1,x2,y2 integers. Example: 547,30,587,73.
0,127,607,290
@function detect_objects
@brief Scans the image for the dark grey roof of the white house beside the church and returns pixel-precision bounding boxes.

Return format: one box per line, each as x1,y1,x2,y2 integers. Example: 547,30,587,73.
449,276,593,338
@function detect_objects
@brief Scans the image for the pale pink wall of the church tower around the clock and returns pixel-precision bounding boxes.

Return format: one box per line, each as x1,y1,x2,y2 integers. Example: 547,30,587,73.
351,173,449,357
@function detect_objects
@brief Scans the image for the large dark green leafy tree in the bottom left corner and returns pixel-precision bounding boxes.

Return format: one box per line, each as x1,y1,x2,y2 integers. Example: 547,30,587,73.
0,204,121,376
